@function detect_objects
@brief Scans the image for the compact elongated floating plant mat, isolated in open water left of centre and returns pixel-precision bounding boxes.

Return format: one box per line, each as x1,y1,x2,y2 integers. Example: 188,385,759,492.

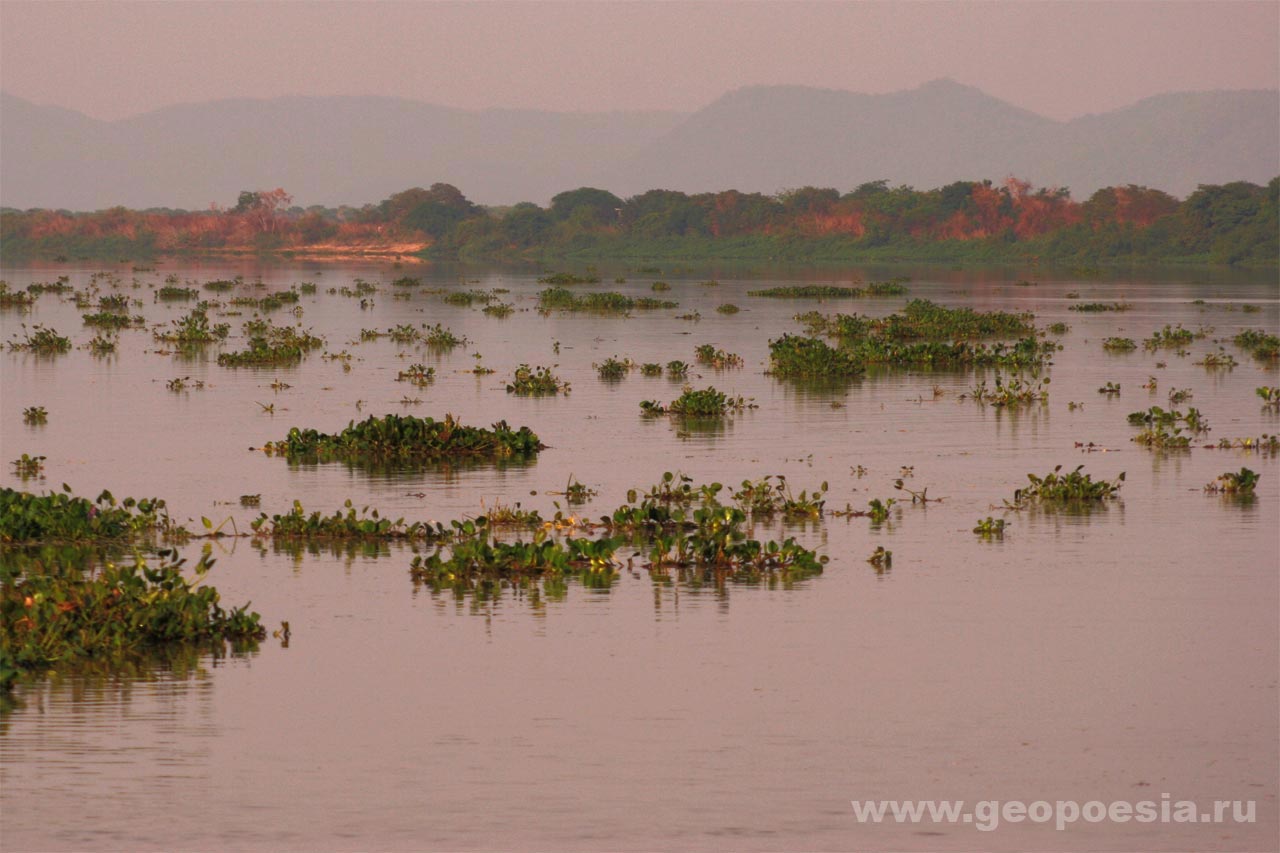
262,415,544,461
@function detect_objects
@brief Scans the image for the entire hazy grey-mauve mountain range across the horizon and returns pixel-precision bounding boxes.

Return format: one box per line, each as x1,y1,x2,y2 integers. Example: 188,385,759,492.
0,79,1280,210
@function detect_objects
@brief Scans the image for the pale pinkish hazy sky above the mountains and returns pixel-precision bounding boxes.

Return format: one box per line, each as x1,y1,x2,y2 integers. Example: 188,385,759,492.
0,0,1280,119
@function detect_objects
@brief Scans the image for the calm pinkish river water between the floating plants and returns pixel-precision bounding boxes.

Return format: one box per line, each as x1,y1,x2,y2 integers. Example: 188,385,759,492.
0,257,1280,850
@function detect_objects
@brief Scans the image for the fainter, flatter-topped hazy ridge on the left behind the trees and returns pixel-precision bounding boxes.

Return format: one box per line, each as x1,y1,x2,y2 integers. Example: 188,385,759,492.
0,95,684,210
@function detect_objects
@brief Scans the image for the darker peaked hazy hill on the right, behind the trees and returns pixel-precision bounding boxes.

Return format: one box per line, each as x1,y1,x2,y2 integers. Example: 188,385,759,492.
605,81,1280,197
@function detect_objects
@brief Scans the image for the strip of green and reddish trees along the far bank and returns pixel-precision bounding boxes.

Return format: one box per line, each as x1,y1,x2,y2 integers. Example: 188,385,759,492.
0,178,1280,265
